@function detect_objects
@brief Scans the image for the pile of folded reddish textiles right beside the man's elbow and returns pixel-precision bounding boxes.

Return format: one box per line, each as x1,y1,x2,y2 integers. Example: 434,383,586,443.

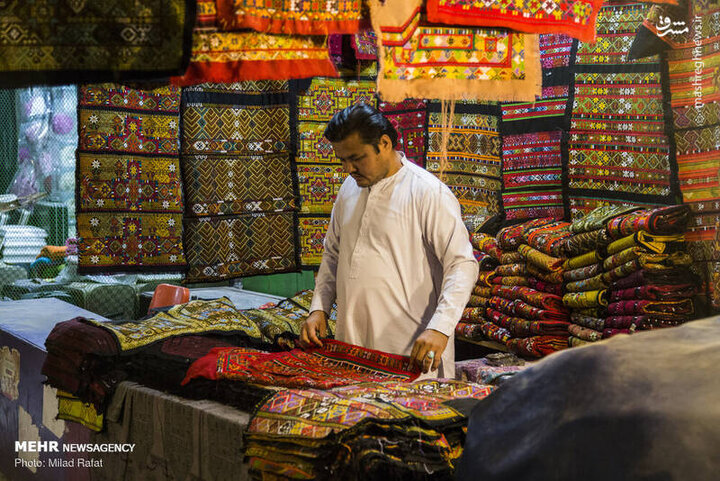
455,224,568,357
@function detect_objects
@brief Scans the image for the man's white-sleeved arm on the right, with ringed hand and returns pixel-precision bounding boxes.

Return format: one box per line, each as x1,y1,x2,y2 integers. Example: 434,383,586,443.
411,188,479,370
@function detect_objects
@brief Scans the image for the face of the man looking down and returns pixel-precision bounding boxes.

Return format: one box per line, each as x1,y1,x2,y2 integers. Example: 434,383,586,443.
332,132,394,187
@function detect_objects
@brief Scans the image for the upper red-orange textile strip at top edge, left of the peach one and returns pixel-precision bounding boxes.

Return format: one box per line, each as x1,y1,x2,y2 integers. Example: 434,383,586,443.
216,0,360,35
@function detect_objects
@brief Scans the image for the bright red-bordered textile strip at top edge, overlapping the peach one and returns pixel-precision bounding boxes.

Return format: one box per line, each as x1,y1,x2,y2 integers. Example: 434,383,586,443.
427,0,603,42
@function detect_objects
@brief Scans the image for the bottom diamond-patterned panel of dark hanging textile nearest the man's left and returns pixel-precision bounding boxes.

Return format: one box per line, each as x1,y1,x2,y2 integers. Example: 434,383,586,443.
185,212,298,282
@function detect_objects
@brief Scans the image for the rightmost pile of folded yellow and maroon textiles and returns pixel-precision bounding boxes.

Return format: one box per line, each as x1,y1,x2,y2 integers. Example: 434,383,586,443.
563,205,697,346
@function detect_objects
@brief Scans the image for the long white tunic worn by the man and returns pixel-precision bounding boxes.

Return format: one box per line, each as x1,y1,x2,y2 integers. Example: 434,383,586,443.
310,154,478,377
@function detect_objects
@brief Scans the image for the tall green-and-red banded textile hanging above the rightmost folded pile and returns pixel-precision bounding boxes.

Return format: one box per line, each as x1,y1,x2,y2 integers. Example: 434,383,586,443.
568,3,677,218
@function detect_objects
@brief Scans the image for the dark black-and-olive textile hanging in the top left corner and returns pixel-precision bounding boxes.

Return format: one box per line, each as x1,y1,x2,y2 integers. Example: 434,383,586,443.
0,0,195,88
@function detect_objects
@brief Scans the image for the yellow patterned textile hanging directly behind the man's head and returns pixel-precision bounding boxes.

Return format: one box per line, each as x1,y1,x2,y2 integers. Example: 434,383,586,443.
295,78,376,267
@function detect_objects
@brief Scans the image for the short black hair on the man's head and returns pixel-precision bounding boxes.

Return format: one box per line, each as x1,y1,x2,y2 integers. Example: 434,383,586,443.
325,103,397,152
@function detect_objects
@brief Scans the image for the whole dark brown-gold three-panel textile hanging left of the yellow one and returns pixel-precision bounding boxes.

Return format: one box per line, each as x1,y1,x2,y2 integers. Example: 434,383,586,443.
182,81,298,281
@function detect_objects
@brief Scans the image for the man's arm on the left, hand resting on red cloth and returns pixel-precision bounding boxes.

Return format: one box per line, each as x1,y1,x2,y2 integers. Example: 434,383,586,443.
300,207,340,346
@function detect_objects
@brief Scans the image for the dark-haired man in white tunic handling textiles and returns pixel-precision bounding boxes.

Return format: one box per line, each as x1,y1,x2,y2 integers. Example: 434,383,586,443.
300,104,478,377
